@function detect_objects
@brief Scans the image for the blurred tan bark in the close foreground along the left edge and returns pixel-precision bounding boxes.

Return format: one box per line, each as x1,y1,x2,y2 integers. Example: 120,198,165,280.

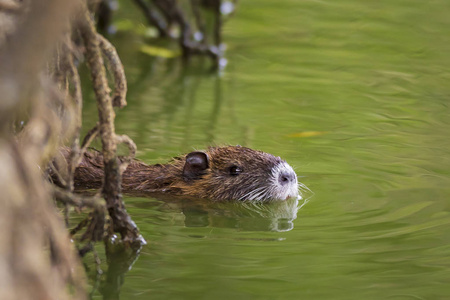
0,0,85,299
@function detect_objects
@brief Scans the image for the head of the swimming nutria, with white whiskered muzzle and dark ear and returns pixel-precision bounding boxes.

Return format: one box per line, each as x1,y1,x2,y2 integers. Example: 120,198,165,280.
179,146,298,201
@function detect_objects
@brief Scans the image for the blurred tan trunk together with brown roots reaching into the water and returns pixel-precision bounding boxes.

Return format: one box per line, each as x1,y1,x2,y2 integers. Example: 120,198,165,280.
0,0,145,299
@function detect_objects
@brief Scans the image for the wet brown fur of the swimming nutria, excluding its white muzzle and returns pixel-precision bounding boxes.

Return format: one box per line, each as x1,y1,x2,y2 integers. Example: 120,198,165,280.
59,146,282,200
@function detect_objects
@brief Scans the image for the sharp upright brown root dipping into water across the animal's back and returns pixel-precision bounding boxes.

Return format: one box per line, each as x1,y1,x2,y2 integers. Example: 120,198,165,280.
79,5,144,245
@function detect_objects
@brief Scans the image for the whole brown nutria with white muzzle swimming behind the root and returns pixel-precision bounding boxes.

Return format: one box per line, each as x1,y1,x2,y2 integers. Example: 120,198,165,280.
60,146,299,201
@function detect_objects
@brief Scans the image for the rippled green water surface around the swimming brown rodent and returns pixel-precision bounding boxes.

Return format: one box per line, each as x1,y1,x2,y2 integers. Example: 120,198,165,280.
86,0,450,300
